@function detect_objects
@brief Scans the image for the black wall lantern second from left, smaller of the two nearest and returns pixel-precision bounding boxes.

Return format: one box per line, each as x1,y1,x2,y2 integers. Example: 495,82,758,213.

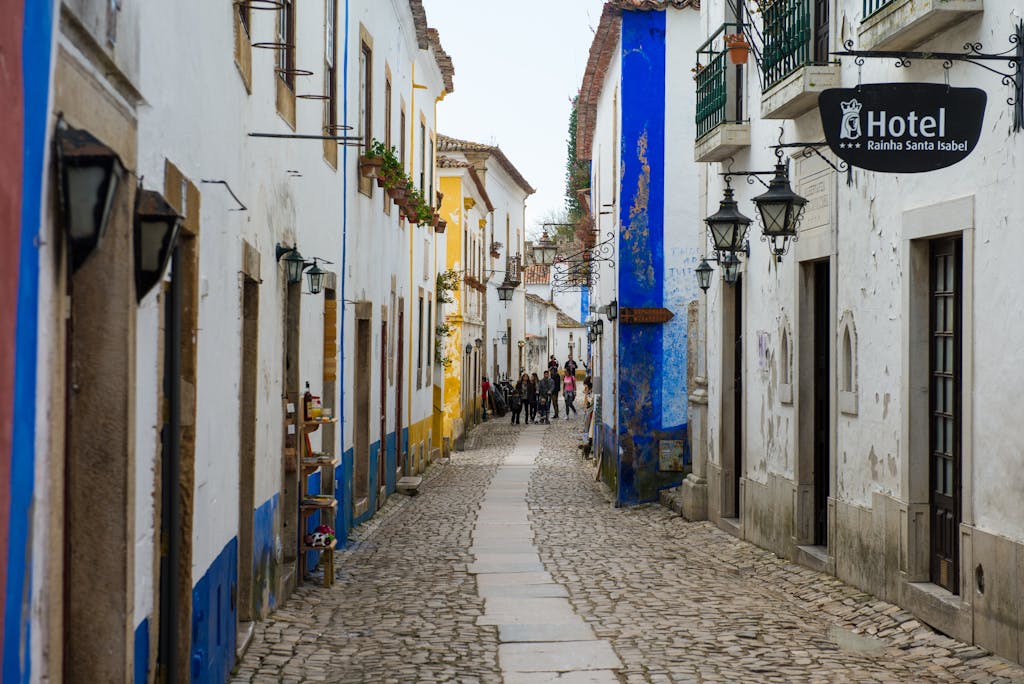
133,188,181,301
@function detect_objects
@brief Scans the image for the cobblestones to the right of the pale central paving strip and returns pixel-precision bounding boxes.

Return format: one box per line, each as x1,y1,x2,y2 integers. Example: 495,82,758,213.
528,424,1024,683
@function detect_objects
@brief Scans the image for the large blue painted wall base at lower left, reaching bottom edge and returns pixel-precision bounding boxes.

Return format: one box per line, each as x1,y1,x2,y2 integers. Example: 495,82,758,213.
190,538,239,682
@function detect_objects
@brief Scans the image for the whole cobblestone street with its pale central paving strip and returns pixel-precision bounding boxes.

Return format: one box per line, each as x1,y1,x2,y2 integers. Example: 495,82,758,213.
233,421,1024,682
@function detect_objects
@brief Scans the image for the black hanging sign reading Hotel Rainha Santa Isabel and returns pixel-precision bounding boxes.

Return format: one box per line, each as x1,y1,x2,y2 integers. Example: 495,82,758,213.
818,83,986,173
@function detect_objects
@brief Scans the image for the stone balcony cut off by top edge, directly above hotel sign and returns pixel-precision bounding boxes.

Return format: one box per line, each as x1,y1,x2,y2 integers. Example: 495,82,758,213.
857,0,984,50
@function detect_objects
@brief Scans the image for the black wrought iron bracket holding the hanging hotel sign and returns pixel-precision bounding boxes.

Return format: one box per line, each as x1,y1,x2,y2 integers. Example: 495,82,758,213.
833,19,1024,133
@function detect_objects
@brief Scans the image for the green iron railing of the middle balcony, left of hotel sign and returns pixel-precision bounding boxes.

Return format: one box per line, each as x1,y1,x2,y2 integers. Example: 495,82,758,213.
761,0,811,90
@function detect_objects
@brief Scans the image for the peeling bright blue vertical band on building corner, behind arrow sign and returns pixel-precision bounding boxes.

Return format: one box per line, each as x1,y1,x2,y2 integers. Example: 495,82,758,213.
615,11,686,506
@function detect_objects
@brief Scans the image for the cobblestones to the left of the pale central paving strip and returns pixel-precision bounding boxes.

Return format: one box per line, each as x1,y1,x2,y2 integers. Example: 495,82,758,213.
232,424,515,683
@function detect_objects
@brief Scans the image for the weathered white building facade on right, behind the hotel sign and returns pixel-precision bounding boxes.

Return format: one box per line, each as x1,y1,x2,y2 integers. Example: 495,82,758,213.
692,0,1024,661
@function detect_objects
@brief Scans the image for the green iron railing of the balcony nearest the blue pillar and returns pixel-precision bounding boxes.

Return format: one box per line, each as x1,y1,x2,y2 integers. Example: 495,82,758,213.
693,24,743,139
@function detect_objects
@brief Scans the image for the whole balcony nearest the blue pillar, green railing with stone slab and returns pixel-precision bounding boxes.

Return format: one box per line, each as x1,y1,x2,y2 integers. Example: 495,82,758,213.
693,24,751,162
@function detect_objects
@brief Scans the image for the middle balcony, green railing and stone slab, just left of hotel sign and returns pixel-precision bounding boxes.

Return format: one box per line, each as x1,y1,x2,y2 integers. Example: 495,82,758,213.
761,0,840,119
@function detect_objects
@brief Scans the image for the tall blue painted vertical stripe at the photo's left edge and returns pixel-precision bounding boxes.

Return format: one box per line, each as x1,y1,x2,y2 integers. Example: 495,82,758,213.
2,0,54,682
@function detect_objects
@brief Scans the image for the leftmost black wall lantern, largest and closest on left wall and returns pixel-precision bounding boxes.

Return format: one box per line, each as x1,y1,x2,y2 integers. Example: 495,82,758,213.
56,125,125,271
